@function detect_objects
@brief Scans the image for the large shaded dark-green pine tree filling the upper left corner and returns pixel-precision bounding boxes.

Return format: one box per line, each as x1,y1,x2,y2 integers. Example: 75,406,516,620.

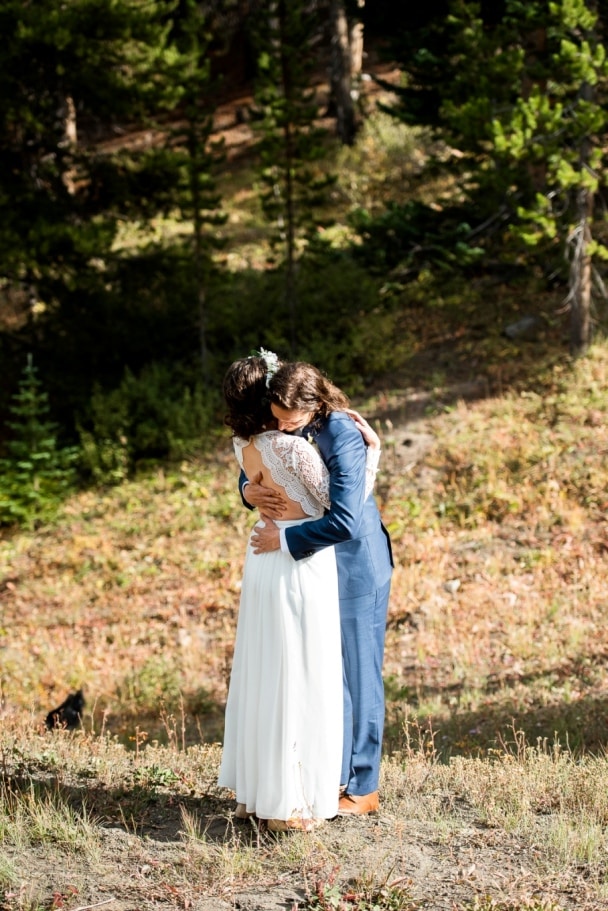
0,0,183,324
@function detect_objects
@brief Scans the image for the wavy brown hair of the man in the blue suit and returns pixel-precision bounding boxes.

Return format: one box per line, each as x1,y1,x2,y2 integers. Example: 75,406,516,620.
268,361,349,417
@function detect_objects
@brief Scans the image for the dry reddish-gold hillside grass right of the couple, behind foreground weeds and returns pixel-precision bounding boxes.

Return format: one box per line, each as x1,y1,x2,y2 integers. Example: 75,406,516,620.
381,346,608,754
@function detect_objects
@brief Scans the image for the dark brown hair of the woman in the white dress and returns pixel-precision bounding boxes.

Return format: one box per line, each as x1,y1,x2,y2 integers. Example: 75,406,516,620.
223,357,274,440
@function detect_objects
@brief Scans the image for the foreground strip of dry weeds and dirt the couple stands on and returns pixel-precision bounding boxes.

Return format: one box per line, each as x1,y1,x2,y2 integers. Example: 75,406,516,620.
0,723,608,911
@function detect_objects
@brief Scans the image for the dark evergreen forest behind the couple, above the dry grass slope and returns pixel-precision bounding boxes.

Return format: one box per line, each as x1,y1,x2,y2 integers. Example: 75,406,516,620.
0,0,606,524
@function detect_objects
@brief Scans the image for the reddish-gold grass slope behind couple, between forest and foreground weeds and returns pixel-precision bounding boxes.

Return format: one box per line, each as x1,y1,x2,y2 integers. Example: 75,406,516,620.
0,346,608,755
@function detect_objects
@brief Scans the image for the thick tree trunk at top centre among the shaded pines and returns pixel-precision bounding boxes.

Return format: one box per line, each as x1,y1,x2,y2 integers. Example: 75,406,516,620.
329,0,357,145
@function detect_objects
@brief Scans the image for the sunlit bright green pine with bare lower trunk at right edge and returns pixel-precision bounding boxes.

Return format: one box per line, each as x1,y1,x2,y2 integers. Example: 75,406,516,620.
493,0,608,354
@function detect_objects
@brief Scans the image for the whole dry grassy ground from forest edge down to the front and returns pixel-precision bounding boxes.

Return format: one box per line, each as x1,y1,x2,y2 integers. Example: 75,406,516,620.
0,340,608,911
